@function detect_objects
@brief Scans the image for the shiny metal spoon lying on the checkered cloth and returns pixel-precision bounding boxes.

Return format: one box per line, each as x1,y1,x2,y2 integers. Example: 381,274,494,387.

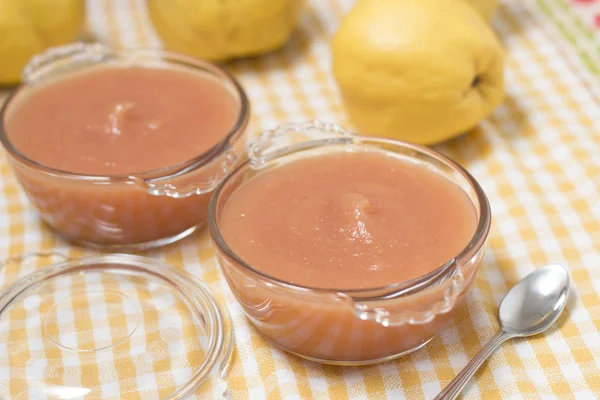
434,265,570,400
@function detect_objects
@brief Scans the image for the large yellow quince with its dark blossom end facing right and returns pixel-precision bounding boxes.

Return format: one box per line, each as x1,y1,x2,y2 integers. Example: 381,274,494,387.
332,0,504,145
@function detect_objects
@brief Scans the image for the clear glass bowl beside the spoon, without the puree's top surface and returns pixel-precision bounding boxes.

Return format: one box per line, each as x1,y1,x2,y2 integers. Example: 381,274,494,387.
208,122,491,365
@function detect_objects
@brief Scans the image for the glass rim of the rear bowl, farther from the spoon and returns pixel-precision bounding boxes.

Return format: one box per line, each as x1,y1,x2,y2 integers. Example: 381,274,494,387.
0,43,250,182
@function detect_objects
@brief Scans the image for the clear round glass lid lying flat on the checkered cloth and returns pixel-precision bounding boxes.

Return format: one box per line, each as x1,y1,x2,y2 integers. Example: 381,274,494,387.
0,254,233,400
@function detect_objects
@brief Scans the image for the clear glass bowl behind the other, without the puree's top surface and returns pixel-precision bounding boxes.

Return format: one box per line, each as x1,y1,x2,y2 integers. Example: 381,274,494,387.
0,43,250,249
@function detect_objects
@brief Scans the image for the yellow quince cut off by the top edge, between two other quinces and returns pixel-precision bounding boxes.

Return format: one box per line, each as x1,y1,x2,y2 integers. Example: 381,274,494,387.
148,0,303,61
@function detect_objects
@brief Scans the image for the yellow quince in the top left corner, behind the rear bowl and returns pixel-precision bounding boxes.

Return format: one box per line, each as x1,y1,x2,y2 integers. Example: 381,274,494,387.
0,0,85,86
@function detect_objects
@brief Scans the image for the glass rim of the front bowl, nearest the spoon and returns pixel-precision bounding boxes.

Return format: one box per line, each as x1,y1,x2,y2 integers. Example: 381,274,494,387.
208,134,492,300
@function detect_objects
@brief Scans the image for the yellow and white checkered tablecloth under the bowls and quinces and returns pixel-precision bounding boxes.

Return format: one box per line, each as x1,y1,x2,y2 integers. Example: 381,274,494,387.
0,0,600,400
